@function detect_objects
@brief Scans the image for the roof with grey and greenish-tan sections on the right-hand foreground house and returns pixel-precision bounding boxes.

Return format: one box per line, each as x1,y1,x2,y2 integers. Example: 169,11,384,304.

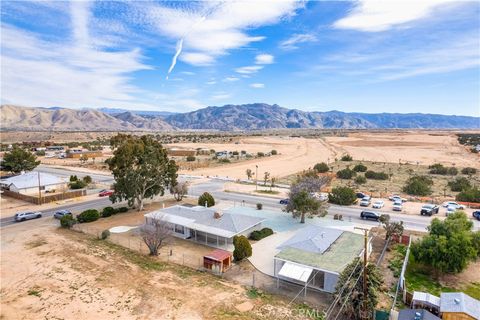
275,226,363,273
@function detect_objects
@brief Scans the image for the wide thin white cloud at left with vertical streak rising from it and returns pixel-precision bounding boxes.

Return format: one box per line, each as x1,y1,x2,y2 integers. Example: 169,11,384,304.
1,7,151,107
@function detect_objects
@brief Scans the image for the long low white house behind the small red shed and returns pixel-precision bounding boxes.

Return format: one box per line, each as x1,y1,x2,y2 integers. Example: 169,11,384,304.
145,205,265,250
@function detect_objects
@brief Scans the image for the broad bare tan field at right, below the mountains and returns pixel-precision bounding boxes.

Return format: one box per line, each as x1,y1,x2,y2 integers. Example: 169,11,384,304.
325,131,480,168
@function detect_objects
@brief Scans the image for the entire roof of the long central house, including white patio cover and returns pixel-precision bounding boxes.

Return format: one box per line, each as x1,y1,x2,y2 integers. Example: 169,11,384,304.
145,205,265,238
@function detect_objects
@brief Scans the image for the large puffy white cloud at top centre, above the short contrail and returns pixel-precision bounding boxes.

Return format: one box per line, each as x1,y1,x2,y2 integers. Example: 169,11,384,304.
130,0,304,65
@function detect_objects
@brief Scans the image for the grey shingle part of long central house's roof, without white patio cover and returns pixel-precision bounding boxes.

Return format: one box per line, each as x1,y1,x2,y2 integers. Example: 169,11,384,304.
148,205,265,236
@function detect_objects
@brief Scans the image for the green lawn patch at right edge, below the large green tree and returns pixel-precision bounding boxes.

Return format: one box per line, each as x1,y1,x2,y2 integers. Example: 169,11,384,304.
405,255,480,299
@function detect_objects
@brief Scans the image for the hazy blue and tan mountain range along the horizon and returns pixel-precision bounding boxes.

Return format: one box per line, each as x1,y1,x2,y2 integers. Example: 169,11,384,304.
0,103,480,131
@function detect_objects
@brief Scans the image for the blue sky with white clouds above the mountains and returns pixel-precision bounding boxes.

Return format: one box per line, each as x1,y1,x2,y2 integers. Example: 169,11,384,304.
1,0,480,116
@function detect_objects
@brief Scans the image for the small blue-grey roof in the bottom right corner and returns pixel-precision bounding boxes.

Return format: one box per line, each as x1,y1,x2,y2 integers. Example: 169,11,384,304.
440,292,480,319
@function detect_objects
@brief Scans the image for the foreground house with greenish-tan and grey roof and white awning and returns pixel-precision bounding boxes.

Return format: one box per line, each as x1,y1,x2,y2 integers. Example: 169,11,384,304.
274,226,370,293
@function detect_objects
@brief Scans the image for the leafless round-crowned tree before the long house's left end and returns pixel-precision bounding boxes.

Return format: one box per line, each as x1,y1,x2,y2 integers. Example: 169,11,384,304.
140,214,172,256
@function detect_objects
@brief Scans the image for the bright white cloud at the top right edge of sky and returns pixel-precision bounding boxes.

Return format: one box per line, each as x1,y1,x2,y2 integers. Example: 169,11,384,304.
334,0,462,32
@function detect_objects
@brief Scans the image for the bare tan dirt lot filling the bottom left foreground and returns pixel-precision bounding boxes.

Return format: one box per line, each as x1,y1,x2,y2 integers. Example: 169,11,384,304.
0,219,318,319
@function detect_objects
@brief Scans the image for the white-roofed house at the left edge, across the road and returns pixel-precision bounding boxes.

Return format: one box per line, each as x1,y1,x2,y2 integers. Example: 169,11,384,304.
0,171,68,195
